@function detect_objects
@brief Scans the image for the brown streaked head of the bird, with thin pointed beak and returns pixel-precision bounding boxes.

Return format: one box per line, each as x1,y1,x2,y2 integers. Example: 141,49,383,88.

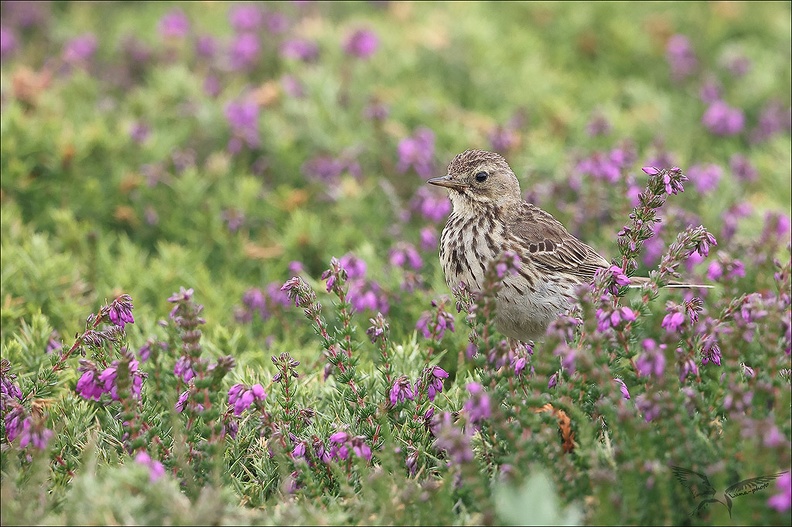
428,150,522,211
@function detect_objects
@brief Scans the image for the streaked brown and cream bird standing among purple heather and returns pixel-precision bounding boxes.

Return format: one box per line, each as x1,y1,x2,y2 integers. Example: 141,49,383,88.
427,150,704,342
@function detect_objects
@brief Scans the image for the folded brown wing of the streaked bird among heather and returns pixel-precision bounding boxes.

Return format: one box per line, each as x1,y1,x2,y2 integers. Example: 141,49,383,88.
509,203,610,281
